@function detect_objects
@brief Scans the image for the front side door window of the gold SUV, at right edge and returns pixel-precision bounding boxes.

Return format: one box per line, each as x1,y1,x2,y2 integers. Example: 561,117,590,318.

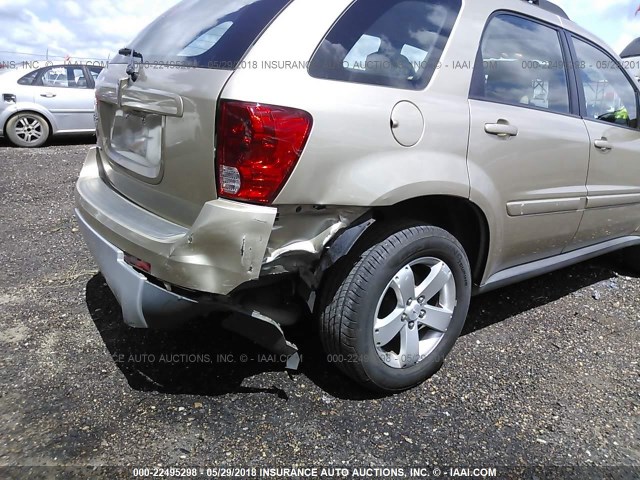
573,38,638,128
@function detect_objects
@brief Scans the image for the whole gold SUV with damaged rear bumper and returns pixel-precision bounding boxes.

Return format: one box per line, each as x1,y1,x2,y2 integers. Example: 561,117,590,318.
76,0,640,391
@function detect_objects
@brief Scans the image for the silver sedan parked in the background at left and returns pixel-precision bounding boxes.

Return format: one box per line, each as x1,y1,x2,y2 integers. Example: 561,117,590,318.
0,65,102,147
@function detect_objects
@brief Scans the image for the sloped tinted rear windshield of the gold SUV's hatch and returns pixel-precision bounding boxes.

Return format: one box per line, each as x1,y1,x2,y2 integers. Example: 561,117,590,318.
111,0,290,70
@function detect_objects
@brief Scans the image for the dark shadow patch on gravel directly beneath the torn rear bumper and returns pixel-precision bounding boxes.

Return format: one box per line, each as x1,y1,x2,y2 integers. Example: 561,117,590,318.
86,274,286,398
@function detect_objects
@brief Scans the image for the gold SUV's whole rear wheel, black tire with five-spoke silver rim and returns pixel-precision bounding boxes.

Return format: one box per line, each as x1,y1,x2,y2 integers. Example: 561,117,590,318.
318,223,471,392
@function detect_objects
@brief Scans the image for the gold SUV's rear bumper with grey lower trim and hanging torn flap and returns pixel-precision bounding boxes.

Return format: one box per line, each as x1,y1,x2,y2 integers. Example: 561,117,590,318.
76,153,297,365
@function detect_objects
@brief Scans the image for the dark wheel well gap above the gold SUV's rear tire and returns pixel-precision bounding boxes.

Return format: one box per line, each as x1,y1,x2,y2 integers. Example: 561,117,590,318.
373,196,490,284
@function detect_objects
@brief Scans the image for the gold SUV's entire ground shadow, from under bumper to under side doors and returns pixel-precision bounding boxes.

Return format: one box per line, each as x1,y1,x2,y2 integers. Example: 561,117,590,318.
86,257,626,400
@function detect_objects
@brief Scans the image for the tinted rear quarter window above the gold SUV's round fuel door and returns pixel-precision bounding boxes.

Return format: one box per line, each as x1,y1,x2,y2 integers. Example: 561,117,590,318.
309,0,461,89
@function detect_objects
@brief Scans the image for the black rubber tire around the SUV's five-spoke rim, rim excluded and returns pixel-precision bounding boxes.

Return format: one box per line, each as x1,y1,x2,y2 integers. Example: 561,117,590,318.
356,230,471,390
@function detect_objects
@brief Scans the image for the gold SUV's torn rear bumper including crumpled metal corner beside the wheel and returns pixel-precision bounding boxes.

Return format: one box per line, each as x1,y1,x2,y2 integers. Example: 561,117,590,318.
76,149,366,372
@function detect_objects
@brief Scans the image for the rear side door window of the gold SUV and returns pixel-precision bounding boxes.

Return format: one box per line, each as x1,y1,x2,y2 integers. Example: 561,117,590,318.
471,14,570,113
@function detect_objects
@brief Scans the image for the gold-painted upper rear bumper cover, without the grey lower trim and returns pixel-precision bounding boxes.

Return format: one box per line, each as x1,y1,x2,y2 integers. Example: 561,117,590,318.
76,148,277,295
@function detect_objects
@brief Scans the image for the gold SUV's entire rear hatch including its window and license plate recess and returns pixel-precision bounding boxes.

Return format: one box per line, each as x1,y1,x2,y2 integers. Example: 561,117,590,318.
96,0,289,226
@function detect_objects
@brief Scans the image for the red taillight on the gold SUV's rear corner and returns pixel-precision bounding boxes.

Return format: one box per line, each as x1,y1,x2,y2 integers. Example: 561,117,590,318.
216,101,313,204
